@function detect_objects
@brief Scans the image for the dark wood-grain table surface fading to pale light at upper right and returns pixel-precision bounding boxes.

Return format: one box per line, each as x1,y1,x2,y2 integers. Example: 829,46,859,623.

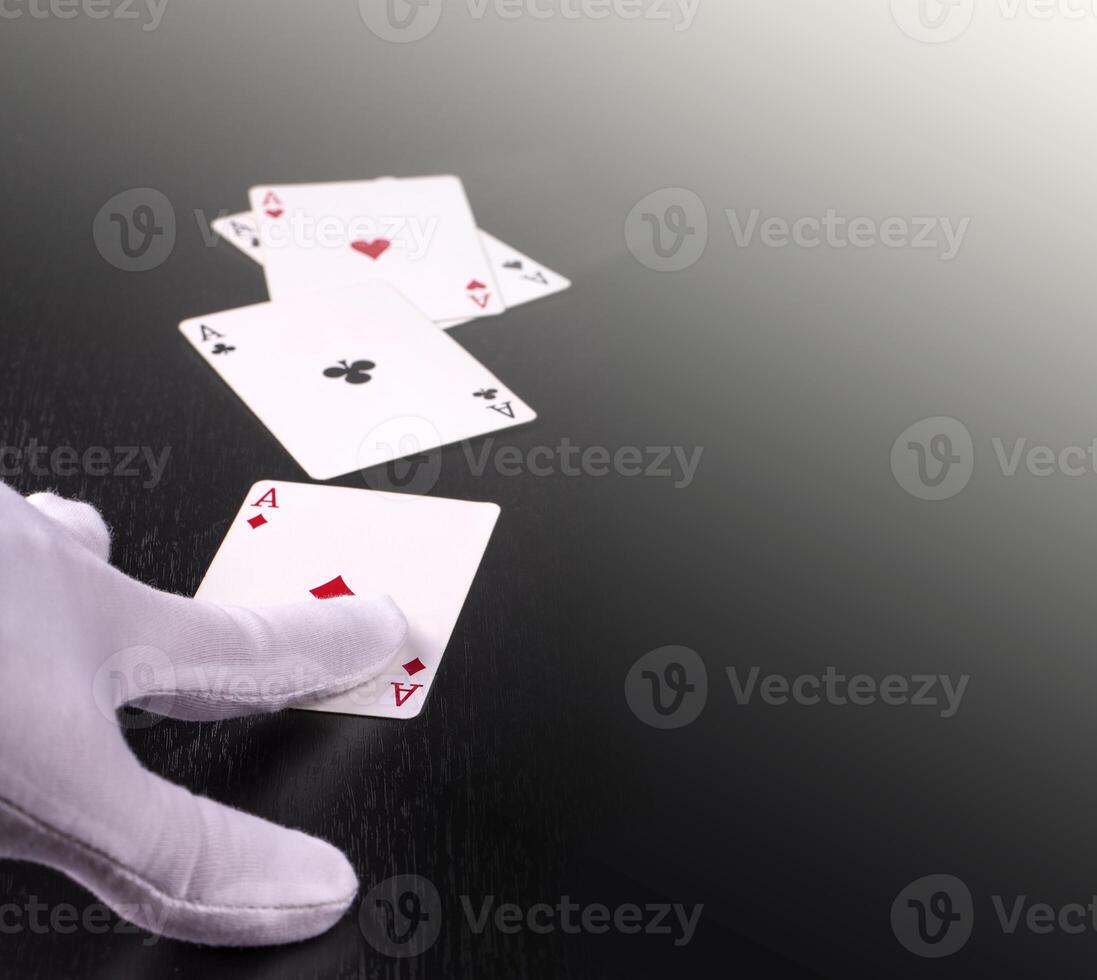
0,0,1097,978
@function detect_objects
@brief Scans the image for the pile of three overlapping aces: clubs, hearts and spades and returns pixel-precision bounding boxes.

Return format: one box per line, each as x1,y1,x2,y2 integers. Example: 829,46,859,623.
188,177,570,480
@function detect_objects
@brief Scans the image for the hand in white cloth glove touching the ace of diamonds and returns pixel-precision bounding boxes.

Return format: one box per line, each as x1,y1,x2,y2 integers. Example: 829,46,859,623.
0,484,407,946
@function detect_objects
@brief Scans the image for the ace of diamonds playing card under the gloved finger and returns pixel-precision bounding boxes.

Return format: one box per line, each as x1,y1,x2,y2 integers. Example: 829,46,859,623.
195,481,499,718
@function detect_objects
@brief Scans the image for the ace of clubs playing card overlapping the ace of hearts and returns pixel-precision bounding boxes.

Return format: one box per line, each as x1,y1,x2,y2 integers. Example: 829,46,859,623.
179,283,536,480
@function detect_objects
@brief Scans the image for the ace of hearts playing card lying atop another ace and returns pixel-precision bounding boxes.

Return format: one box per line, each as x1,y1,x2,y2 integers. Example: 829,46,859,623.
250,177,506,320
